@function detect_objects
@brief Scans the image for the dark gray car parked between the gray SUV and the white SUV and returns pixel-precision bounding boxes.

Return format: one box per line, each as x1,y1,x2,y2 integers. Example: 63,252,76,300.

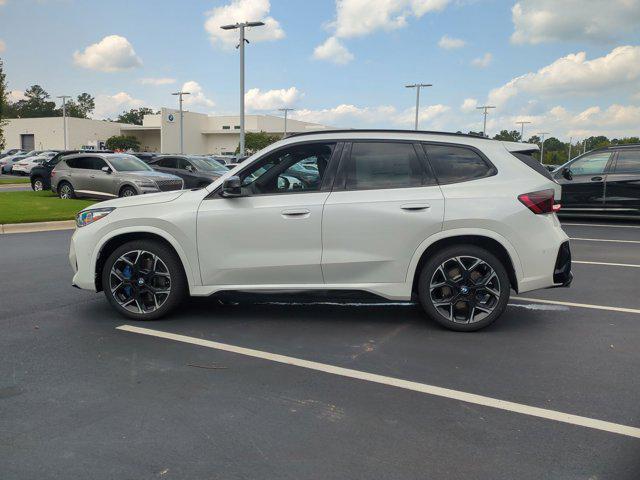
149,155,229,188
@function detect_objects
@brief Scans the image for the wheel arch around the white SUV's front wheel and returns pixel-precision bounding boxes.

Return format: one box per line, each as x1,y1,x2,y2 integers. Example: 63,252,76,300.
92,227,195,292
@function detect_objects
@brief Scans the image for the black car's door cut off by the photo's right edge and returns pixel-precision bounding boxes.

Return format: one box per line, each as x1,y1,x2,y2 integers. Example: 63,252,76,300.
605,148,640,214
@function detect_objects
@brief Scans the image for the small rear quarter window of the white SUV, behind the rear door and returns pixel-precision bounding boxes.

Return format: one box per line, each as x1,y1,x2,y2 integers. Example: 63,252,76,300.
424,145,493,183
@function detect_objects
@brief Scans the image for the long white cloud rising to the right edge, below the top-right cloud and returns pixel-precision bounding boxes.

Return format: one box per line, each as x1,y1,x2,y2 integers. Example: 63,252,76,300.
489,45,640,105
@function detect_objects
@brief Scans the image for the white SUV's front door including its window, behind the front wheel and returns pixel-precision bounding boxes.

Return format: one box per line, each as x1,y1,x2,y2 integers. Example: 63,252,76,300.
197,142,337,286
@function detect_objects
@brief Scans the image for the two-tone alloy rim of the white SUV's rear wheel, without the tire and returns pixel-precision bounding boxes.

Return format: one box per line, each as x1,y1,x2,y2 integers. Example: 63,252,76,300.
429,256,501,324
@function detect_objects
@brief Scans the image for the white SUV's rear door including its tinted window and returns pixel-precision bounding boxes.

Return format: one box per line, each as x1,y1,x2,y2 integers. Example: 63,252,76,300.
322,140,444,284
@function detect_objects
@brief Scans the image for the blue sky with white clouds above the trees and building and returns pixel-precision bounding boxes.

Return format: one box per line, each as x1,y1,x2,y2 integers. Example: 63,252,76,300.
0,0,640,141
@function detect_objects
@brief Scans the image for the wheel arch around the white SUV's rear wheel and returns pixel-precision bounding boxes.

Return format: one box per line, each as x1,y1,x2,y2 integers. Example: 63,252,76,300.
409,229,522,293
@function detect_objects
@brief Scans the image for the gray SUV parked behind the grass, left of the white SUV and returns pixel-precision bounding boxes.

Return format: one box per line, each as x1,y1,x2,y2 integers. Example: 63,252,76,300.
51,153,184,198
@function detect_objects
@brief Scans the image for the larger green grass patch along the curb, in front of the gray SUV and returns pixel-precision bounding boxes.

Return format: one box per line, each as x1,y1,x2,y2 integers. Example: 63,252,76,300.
0,191,95,224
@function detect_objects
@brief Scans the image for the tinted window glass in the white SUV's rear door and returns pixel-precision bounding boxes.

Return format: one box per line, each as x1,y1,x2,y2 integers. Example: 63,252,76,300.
347,142,425,190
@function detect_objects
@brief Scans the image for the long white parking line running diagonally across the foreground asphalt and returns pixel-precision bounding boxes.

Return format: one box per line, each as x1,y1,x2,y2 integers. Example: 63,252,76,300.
116,325,640,438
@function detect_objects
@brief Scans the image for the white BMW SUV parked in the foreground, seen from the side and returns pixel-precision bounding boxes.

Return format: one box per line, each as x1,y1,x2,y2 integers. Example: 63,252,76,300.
69,130,572,331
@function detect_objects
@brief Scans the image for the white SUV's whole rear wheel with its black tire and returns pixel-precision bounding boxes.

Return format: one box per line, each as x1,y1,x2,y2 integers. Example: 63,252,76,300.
418,245,511,332
